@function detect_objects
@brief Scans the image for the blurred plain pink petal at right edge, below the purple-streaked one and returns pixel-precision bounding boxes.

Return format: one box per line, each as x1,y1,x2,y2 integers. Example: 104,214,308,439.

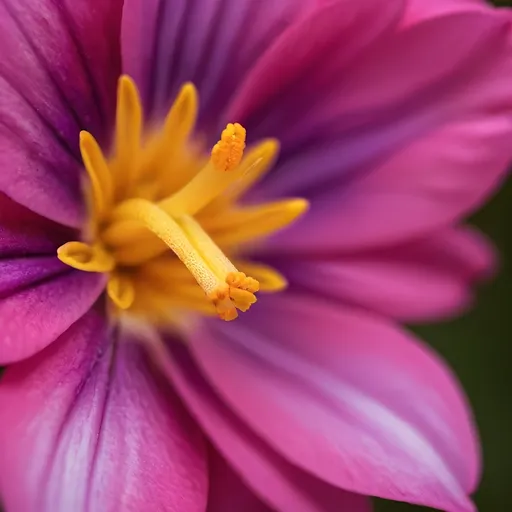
276,110,512,252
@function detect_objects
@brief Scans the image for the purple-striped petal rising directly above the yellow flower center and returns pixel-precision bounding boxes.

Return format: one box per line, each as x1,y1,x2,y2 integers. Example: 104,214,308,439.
122,0,316,129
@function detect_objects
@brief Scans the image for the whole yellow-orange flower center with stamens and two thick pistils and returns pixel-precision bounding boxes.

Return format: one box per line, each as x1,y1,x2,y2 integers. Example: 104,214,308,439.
57,76,307,323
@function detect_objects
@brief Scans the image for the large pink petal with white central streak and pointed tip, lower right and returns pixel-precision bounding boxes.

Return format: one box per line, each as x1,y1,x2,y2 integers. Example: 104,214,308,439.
190,294,479,512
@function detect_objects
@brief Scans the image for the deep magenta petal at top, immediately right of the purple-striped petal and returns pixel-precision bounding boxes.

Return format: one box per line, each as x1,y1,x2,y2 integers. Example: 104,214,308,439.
228,0,404,142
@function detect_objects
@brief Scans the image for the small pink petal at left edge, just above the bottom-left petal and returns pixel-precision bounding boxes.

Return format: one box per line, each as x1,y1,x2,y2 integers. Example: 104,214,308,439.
0,268,105,365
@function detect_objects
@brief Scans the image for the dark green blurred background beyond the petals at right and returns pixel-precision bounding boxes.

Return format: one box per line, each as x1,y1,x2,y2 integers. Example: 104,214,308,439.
376,4,512,512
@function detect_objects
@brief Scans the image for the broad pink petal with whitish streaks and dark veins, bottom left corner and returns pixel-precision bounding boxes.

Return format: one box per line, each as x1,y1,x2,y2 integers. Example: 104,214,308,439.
0,311,207,512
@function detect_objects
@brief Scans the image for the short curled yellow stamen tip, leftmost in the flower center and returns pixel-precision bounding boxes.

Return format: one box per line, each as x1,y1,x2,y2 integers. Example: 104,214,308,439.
57,242,115,272
